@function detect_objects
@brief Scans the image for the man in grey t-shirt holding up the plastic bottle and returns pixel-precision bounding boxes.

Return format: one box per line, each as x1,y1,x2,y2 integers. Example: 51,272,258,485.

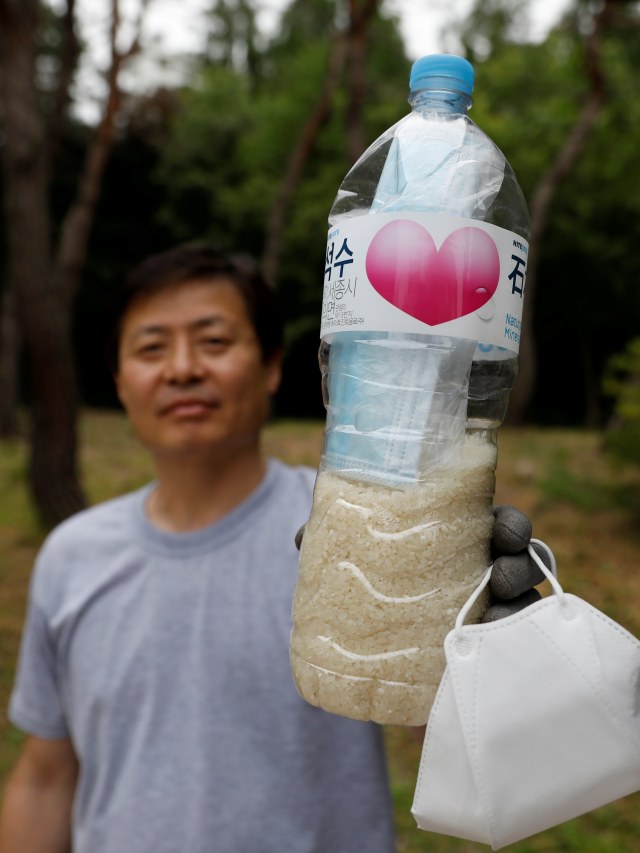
0,246,548,853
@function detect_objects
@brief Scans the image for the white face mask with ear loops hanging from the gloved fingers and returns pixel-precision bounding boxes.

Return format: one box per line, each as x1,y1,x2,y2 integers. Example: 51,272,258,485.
412,546,640,850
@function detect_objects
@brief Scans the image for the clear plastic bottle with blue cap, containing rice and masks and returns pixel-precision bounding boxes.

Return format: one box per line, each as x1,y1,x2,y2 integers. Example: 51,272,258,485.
291,55,529,725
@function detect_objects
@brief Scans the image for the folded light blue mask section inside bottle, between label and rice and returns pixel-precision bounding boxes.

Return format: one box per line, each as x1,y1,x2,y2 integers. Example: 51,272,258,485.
322,333,476,486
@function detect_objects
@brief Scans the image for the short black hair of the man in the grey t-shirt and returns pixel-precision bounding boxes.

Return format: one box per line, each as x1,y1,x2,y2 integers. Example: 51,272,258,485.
107,243,284,372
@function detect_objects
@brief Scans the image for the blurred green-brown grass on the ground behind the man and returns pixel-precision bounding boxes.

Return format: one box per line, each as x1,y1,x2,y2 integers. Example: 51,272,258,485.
0,411,640,853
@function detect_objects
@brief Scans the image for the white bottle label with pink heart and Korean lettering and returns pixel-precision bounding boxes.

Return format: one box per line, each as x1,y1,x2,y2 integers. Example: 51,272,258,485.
320,211,529,353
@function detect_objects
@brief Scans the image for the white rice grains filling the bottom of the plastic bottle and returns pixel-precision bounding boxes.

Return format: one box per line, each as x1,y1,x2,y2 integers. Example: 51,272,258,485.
291,436,496,725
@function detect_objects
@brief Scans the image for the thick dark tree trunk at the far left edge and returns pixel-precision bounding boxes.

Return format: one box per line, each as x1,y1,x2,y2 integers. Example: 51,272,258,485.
0,0,85,525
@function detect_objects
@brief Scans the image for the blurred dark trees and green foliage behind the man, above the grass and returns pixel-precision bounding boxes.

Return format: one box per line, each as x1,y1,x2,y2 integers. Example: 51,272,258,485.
0,0,640,524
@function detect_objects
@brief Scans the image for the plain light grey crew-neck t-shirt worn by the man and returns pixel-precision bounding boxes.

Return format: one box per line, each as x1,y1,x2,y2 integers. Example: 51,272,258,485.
10,460,394,853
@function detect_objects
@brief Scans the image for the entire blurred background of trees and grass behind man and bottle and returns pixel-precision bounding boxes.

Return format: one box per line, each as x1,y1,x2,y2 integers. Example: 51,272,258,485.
0,0,640,853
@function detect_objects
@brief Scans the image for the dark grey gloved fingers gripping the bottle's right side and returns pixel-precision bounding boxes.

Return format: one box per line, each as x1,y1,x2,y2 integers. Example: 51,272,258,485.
482,506,551,622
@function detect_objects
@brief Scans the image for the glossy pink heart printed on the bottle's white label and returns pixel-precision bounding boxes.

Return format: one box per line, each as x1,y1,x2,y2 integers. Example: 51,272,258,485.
366,219,500,326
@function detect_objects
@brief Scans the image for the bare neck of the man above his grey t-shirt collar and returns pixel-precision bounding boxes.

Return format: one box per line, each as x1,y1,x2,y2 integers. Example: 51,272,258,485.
147,448,267,533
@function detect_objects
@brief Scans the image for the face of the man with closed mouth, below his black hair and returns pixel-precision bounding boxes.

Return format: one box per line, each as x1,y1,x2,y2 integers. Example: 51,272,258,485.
115,279,280,457
